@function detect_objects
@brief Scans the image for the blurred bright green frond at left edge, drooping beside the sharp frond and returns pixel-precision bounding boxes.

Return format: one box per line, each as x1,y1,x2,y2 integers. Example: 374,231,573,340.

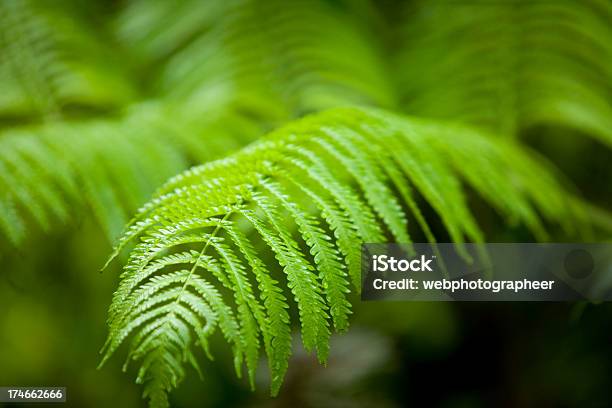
0,103,261,244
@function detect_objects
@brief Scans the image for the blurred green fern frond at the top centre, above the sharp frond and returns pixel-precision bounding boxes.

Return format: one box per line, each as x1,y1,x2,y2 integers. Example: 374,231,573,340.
117,0,394,113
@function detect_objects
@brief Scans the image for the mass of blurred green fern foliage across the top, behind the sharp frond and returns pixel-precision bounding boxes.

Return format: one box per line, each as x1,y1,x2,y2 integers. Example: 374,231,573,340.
0,0,612,249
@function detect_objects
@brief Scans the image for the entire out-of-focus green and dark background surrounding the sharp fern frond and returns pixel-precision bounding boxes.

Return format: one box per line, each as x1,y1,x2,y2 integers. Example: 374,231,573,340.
0,0,612,408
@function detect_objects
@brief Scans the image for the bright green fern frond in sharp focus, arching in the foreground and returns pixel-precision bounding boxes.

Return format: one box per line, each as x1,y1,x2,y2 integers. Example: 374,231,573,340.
103,108,582,406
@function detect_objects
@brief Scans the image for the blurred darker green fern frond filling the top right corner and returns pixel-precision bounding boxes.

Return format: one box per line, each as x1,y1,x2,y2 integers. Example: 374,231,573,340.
396,0,612,145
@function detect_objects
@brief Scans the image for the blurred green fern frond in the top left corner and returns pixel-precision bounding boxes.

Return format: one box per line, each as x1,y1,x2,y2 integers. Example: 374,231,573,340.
0,0,136,119
